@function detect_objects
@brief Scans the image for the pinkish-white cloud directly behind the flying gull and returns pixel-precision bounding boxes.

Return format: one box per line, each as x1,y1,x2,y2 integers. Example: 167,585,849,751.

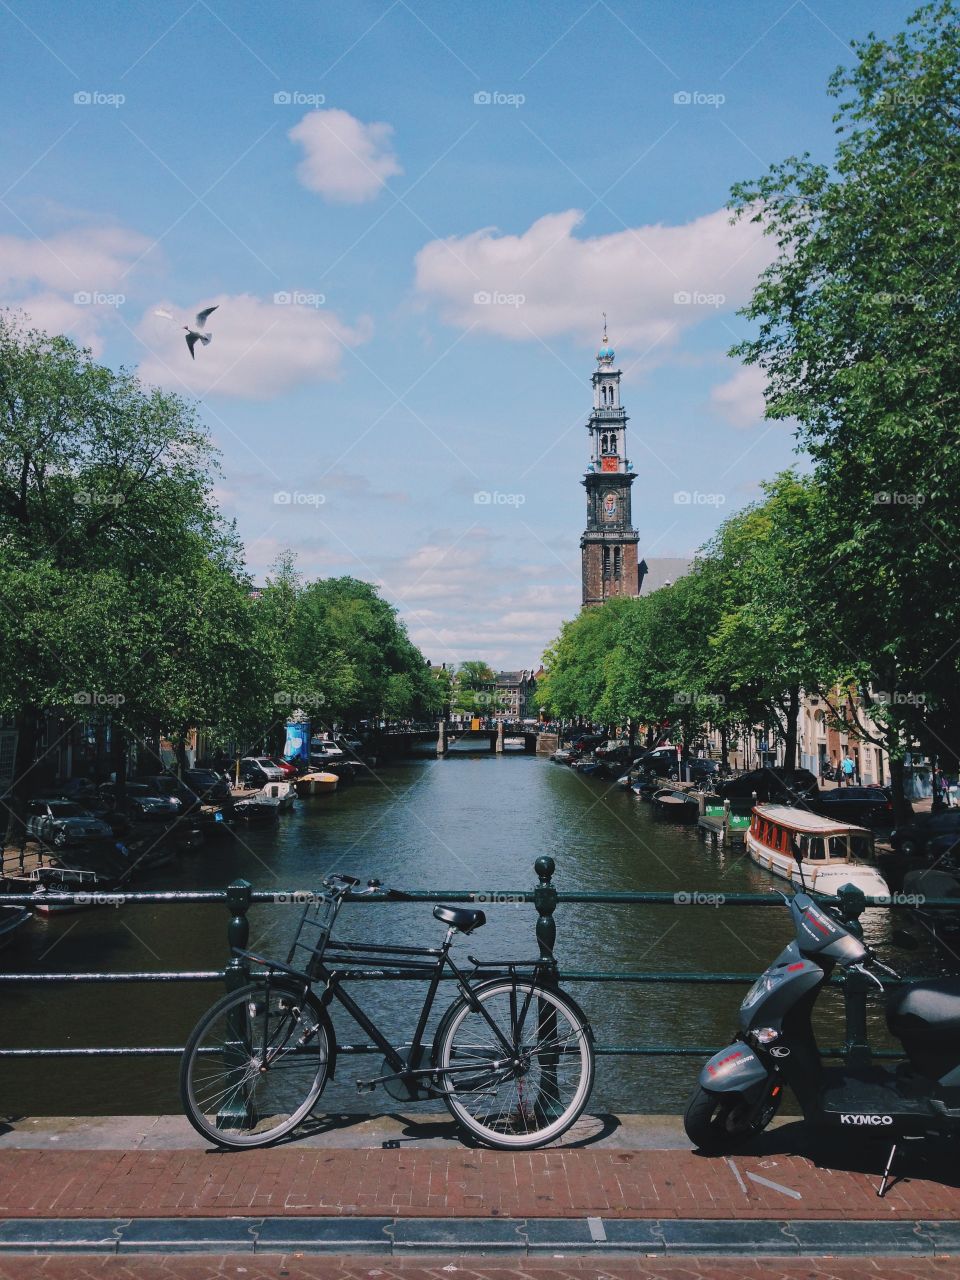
137,293,371,399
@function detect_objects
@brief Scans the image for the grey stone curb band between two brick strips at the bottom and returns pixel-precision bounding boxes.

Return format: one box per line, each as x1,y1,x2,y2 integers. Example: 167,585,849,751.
0,1217,960,1258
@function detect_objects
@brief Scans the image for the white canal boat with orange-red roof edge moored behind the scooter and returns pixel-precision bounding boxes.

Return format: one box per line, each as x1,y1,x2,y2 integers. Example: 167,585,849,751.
745,804,890,899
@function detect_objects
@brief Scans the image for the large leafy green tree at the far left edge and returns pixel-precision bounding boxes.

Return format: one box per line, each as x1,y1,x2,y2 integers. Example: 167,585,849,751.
0,312,227,838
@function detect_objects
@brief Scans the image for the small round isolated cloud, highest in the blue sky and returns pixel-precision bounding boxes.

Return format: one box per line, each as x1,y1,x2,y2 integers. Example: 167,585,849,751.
288,108,403,205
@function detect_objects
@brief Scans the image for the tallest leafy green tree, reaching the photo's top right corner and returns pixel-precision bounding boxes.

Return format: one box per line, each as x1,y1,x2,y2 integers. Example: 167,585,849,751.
732,0,960,814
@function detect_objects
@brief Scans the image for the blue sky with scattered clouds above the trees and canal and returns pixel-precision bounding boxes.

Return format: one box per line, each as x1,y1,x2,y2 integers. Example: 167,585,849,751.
0,0,914,669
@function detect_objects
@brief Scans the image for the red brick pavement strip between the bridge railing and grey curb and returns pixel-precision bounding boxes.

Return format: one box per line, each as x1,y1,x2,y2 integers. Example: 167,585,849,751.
0,1144,960,1221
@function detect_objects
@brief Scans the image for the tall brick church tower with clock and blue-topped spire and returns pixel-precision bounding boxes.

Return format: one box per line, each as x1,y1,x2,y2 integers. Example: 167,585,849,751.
580,327,646,607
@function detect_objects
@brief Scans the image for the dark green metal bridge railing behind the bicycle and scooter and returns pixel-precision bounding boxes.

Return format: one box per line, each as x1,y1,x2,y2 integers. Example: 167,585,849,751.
0,858,960,1059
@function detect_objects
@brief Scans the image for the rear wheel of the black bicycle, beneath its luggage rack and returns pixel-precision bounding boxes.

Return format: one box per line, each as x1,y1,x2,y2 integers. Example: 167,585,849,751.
434,978,594,1151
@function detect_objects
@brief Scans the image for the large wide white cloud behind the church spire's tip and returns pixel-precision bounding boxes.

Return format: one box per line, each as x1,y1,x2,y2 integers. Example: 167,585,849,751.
416,209,773,351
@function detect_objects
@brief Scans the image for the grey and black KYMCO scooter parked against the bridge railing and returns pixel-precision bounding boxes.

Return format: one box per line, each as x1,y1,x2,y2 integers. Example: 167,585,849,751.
684,849,960,1197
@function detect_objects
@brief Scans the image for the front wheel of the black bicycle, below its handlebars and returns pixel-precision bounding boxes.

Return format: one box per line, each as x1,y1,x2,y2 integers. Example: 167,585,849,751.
180,982,332,1149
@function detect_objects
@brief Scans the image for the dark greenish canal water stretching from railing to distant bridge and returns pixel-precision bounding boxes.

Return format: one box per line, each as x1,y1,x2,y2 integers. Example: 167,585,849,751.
0,754,929,1115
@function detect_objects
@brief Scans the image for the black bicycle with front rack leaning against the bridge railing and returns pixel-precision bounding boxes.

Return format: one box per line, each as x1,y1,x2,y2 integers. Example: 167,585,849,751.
180,874,594,1151
